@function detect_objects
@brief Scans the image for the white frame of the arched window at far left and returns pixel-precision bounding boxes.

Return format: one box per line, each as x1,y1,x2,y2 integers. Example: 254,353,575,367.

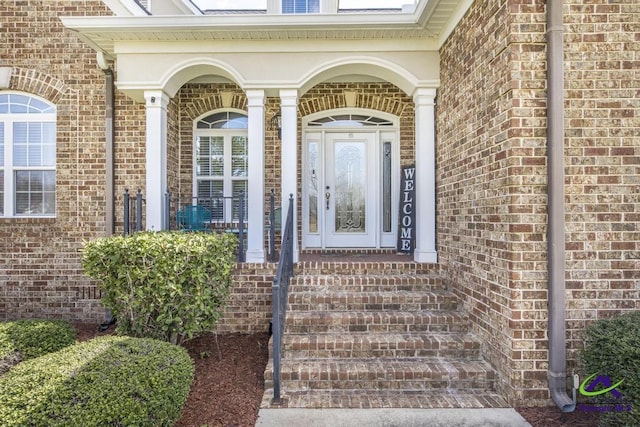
0,91,58,218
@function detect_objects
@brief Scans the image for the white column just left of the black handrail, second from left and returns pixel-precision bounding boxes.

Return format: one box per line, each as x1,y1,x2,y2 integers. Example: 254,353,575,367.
245,89,265,262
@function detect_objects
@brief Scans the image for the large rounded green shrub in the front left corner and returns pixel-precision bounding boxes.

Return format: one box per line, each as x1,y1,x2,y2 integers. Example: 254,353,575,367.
0,336,194,427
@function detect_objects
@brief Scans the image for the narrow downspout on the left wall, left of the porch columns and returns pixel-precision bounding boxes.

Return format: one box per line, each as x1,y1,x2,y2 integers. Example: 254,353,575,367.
96,52,115,236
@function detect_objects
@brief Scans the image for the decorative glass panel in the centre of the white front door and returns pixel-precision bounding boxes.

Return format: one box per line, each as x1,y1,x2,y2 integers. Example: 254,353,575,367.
334,142,367,233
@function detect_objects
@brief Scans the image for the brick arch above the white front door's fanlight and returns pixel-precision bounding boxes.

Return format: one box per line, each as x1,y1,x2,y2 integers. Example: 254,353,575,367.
299,83,413,117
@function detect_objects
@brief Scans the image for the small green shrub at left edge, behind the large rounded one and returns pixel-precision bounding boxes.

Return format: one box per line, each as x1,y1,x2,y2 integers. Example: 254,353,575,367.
0,319,76,374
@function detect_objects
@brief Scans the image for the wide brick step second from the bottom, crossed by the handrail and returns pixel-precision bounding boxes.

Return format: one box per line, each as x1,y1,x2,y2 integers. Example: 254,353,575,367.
264,358,495,391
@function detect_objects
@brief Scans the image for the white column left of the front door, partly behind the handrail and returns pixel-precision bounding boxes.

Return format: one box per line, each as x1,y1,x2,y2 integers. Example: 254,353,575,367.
280,89,300,262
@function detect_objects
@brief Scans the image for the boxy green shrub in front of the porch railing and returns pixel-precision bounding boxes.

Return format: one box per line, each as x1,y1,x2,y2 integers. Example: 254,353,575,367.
82,232,237,344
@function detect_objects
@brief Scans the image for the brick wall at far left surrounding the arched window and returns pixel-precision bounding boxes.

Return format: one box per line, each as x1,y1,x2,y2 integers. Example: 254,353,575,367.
0,0,108,320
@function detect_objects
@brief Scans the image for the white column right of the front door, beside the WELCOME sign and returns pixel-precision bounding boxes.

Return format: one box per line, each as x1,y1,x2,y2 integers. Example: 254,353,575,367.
413,88,438,263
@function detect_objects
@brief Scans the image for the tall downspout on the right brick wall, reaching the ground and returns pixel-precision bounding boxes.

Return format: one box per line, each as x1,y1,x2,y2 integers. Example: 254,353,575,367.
547,0,576,412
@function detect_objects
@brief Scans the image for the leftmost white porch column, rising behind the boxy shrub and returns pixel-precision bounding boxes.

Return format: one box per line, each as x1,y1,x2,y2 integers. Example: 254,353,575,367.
144,90,169,231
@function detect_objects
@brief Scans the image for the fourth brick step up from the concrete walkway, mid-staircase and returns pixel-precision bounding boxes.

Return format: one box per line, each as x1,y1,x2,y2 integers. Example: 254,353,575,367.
285,311,468,335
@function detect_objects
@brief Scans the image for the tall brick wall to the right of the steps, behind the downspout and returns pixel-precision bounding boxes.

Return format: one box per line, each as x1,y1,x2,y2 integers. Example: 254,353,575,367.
437,0,640,405
